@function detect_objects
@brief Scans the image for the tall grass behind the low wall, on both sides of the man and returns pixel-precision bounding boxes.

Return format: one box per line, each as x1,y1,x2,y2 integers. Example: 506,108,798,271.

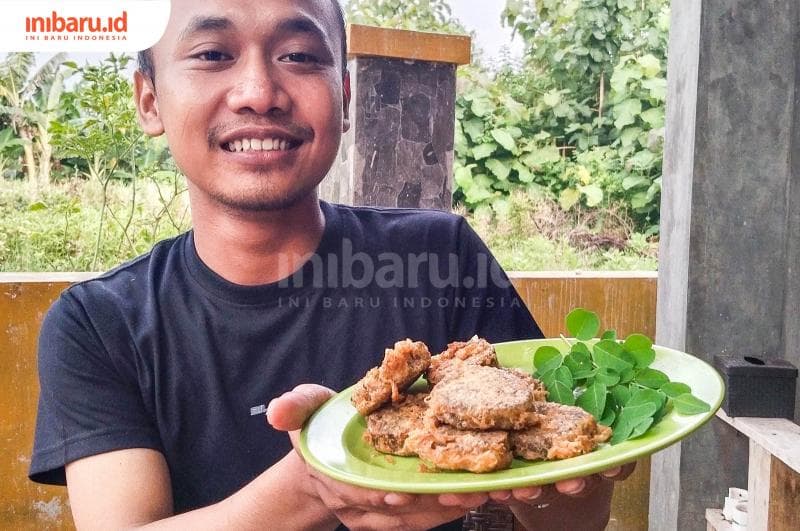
0,180,657,272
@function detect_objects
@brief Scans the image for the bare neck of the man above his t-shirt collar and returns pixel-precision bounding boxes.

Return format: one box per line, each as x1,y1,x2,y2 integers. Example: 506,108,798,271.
192,193,325,286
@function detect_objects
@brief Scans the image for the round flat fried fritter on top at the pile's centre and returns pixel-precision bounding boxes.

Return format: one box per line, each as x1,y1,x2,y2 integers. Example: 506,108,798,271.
428,366,539,430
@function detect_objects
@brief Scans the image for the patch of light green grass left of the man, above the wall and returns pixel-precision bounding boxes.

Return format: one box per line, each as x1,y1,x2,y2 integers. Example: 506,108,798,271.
0,179,190,272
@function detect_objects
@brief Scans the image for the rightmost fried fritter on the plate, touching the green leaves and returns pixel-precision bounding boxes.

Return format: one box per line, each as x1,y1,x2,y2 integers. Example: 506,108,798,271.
510,402,611,460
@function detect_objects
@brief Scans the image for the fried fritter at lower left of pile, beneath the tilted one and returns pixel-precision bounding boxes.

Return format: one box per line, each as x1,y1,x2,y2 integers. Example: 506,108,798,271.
364,393,428,456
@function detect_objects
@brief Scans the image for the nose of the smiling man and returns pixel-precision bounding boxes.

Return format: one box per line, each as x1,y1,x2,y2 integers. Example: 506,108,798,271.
227,53,291,114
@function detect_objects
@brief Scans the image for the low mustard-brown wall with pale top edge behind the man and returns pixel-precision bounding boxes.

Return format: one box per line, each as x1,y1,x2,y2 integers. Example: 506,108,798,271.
0,273,656,531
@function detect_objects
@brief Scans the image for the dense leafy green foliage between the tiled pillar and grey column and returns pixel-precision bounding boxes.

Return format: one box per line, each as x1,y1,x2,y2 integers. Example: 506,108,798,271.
455,0,669,234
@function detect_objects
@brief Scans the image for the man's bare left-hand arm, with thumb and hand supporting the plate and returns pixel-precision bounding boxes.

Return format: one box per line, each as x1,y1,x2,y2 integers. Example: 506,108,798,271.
66,384,487,530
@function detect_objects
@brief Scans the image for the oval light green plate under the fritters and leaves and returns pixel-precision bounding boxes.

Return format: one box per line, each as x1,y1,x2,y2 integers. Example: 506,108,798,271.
300,339,724,493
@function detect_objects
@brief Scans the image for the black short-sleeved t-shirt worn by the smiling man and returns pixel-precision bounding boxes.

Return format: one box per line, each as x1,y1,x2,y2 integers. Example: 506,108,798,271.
30,202,541,524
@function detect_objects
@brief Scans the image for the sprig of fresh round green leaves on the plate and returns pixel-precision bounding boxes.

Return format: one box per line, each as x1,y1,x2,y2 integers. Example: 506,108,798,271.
533,308,711,444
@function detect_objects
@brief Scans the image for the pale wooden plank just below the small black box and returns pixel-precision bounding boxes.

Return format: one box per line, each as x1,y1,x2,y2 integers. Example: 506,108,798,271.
717,409,800,472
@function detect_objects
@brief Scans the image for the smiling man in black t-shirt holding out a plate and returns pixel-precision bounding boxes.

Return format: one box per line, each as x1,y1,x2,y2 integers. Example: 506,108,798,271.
31,0,625,529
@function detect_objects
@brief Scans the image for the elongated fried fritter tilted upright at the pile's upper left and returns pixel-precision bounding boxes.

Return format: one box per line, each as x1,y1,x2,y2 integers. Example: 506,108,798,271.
351,339,431,415
